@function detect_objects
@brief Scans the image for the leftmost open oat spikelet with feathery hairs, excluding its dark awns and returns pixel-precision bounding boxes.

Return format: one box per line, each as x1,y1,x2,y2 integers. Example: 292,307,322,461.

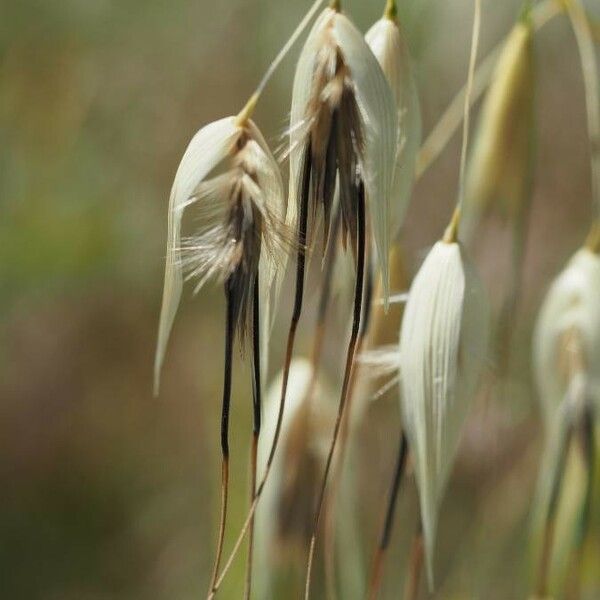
154,117,285,393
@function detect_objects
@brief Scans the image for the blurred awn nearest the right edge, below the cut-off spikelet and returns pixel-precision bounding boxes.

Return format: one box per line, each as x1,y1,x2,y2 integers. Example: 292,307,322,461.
567,407,596,600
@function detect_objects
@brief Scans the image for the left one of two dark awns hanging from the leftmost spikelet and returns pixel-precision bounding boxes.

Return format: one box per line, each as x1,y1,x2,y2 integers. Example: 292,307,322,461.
210,278,235,588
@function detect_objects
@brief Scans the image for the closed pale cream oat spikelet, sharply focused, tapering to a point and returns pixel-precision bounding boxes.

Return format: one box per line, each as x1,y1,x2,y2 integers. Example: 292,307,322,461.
399,241,489,587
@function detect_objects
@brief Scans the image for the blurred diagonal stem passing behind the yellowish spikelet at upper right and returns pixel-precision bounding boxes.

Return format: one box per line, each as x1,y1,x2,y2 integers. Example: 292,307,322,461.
415,0,562,179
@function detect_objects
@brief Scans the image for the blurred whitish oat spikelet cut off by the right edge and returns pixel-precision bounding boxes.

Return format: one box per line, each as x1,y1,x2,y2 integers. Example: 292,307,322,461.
533,247,600,594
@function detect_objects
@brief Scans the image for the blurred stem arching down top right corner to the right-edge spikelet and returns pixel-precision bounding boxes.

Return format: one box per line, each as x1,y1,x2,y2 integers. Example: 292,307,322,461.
564,0,600,219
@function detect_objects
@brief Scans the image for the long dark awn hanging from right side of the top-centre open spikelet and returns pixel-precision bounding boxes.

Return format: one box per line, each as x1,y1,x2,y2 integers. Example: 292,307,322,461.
304,182,366,600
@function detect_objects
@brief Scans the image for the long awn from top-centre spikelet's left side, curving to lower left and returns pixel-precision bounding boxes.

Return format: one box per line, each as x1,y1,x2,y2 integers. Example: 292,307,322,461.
207,142,312,600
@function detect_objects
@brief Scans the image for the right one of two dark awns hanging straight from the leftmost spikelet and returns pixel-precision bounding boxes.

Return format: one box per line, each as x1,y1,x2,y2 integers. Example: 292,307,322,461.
244,273,262,600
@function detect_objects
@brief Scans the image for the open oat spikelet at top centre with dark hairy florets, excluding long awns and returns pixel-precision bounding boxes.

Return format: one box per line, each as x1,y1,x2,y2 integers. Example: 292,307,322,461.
287,8,397,297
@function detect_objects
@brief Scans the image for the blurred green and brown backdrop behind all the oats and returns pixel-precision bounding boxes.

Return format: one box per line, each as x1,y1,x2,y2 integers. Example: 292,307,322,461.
0,0,600,600
